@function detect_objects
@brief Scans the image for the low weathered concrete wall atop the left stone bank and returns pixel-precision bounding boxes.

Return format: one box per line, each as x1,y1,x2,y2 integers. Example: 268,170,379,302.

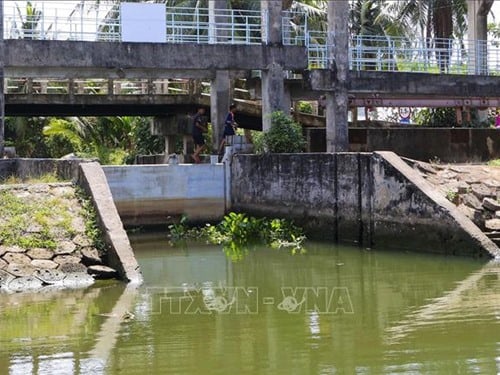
0,158,89,181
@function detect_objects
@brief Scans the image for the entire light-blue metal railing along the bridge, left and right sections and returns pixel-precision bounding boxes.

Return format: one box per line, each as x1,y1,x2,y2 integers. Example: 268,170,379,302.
4,0,500,75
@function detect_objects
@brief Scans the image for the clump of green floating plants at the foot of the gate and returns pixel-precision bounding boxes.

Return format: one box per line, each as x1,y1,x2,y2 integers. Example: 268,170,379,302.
168,212,306,261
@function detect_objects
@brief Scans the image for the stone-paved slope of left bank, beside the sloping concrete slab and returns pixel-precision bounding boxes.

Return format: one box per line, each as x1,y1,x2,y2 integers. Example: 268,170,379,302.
0,183,116,292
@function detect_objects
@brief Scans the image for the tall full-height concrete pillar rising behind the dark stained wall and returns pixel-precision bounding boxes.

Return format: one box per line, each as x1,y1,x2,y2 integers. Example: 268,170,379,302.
325,0,349,152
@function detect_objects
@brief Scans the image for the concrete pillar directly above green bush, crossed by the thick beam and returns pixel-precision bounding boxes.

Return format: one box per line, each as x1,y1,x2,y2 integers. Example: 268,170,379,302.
261,0,284,131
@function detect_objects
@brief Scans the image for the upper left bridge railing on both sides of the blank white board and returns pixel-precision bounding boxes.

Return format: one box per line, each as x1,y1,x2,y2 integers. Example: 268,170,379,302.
4,0,263,44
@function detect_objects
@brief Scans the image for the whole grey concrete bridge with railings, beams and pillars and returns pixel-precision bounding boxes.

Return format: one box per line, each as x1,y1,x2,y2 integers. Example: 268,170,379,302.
0,1,500,156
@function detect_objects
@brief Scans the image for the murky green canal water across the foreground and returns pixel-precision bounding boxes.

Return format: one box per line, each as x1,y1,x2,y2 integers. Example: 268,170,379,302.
0,235,500,375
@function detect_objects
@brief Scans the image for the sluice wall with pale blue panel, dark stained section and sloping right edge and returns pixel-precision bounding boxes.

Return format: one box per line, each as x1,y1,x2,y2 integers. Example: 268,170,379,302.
99,152,500,258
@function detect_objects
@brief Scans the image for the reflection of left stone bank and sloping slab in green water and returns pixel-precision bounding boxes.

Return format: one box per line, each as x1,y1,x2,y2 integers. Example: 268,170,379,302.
0,282,136,375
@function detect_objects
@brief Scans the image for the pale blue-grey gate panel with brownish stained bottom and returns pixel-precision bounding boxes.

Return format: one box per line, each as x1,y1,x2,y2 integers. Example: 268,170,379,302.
103,164,226,226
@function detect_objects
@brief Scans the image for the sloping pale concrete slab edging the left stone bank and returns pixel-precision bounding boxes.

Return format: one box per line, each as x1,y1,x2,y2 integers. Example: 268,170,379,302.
78,162,143,284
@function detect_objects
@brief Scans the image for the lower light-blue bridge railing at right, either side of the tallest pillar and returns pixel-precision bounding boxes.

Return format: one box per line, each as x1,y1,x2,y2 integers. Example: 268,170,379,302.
306,31,500,75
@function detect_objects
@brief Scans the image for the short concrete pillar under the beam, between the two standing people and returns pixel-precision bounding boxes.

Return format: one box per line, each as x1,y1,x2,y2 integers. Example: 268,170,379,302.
210,70,231,150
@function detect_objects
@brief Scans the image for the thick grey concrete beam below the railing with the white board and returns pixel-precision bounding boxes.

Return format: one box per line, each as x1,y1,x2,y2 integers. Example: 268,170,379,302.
5,40,307,78
